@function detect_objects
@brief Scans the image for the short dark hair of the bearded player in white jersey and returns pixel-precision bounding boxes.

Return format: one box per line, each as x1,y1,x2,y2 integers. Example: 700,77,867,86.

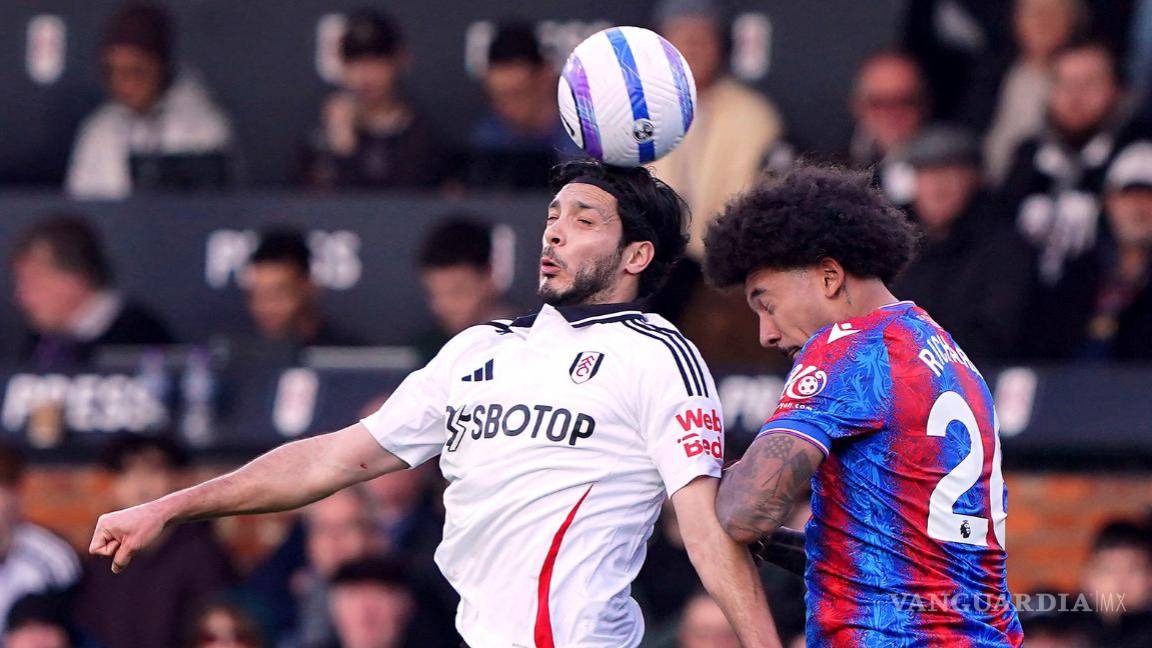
552,159,690,297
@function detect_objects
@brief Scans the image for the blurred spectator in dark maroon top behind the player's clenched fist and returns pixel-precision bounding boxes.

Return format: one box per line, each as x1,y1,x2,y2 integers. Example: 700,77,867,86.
74,435,233,648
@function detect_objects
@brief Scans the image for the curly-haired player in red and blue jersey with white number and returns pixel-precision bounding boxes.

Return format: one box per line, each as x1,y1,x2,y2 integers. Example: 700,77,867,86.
706,166,1023,648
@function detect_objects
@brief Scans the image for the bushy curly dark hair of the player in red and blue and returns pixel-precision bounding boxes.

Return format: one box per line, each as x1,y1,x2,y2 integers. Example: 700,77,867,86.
705,165,917,288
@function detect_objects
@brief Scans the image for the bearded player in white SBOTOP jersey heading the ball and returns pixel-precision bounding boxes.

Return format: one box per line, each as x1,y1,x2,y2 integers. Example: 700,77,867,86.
90,160,779,648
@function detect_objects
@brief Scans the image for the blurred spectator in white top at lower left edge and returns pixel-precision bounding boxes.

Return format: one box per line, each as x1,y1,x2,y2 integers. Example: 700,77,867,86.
0,445,79,646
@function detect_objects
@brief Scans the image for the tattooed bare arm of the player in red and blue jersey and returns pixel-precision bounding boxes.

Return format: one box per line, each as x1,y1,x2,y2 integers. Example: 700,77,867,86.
717,432,824,544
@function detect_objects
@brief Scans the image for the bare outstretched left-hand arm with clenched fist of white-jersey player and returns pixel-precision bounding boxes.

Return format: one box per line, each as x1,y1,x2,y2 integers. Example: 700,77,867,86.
89,423,408,572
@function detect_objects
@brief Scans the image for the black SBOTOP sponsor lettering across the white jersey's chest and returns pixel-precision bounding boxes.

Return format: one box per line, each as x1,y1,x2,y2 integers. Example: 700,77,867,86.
445,402,596,452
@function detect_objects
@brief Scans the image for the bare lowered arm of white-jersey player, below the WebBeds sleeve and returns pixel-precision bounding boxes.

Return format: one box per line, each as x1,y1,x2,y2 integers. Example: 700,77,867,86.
672,476,781,648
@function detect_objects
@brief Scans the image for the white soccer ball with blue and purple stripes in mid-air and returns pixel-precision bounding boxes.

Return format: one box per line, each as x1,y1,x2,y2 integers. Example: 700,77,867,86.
556,27,696,166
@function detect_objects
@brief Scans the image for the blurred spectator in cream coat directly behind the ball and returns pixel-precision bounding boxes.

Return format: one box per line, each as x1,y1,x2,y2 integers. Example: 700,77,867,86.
652,0,783,261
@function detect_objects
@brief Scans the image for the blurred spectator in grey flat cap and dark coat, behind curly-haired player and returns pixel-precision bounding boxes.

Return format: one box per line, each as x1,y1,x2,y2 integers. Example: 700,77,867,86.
893,127,1031,359
